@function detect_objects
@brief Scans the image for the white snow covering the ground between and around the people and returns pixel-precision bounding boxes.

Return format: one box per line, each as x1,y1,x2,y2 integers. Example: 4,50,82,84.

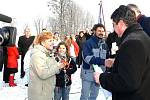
0,63,111,100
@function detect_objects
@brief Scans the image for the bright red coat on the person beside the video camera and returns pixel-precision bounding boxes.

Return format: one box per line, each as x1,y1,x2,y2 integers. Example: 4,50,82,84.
7,46,19,68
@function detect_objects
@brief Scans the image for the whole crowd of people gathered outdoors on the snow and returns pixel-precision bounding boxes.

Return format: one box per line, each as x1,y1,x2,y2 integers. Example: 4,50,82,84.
0,4,150,100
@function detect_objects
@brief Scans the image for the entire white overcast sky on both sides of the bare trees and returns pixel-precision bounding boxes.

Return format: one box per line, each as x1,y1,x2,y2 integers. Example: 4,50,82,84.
0,0,150,34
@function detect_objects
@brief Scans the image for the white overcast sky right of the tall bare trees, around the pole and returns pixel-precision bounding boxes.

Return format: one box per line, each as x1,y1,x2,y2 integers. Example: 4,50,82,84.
75,0,150,31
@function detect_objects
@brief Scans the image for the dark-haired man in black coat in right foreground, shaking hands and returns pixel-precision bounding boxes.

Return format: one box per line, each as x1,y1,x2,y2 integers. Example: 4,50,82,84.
94,5,150,100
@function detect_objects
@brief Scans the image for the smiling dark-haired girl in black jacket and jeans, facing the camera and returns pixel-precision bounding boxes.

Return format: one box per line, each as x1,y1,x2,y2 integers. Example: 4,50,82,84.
54,42,77,100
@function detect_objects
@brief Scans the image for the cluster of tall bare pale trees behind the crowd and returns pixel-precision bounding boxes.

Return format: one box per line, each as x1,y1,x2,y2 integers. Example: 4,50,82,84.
48,0,94,33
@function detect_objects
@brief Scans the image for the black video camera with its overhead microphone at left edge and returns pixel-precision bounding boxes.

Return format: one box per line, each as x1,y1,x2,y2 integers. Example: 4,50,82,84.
0,14,17,46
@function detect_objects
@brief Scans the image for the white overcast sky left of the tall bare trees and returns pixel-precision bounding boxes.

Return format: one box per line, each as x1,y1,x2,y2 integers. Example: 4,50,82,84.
0,0,48,34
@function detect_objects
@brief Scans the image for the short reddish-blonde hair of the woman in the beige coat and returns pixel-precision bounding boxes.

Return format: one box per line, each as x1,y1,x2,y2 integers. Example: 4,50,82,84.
35,32,53,44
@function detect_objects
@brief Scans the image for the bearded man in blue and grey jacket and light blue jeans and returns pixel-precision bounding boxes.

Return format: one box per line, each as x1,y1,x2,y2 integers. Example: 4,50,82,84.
80,24,107,100
